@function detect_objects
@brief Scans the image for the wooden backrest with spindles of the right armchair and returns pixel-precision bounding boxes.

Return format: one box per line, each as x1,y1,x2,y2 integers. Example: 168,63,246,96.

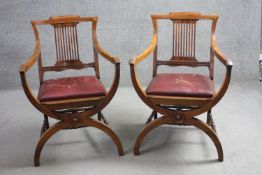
152,12,218,79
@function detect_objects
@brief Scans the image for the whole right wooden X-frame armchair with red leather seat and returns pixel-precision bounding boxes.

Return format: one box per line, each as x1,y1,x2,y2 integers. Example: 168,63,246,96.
130,12,233,161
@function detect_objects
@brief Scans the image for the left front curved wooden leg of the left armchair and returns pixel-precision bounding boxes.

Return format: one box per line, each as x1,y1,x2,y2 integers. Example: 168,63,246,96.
34,122,66,166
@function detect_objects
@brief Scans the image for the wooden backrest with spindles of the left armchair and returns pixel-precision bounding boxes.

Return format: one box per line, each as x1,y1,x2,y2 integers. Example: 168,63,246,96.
32,16,100,83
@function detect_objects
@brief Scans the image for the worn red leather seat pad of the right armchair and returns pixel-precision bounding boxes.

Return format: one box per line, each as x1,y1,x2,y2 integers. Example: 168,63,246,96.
146,73,214,97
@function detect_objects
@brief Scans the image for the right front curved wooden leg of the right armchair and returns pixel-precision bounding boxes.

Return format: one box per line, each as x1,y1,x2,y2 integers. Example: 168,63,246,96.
190,118,224,162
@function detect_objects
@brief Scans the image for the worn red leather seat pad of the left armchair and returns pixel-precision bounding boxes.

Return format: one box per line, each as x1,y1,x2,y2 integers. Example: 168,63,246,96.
38,76,106,101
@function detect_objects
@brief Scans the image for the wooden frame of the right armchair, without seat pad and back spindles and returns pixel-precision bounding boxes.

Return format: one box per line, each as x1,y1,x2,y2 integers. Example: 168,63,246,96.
130,12,233,161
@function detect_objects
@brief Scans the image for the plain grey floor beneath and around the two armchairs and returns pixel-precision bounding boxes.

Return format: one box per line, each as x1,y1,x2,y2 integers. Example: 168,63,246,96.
0,81,262,175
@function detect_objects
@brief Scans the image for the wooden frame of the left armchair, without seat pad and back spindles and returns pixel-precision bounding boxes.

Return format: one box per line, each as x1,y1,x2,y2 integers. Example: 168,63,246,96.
19,16,123,166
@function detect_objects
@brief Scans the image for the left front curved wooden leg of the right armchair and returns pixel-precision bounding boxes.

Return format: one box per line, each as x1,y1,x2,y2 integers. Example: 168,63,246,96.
134,116,167,155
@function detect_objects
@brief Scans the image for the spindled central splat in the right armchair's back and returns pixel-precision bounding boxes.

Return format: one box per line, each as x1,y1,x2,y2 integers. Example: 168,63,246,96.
171,20,197,62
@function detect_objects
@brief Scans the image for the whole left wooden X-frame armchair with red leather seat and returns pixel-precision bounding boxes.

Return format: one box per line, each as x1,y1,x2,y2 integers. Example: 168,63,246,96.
19,16,123,166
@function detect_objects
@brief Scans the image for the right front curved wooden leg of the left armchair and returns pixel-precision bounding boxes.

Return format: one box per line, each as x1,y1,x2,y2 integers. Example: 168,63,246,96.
83,119,124,156
